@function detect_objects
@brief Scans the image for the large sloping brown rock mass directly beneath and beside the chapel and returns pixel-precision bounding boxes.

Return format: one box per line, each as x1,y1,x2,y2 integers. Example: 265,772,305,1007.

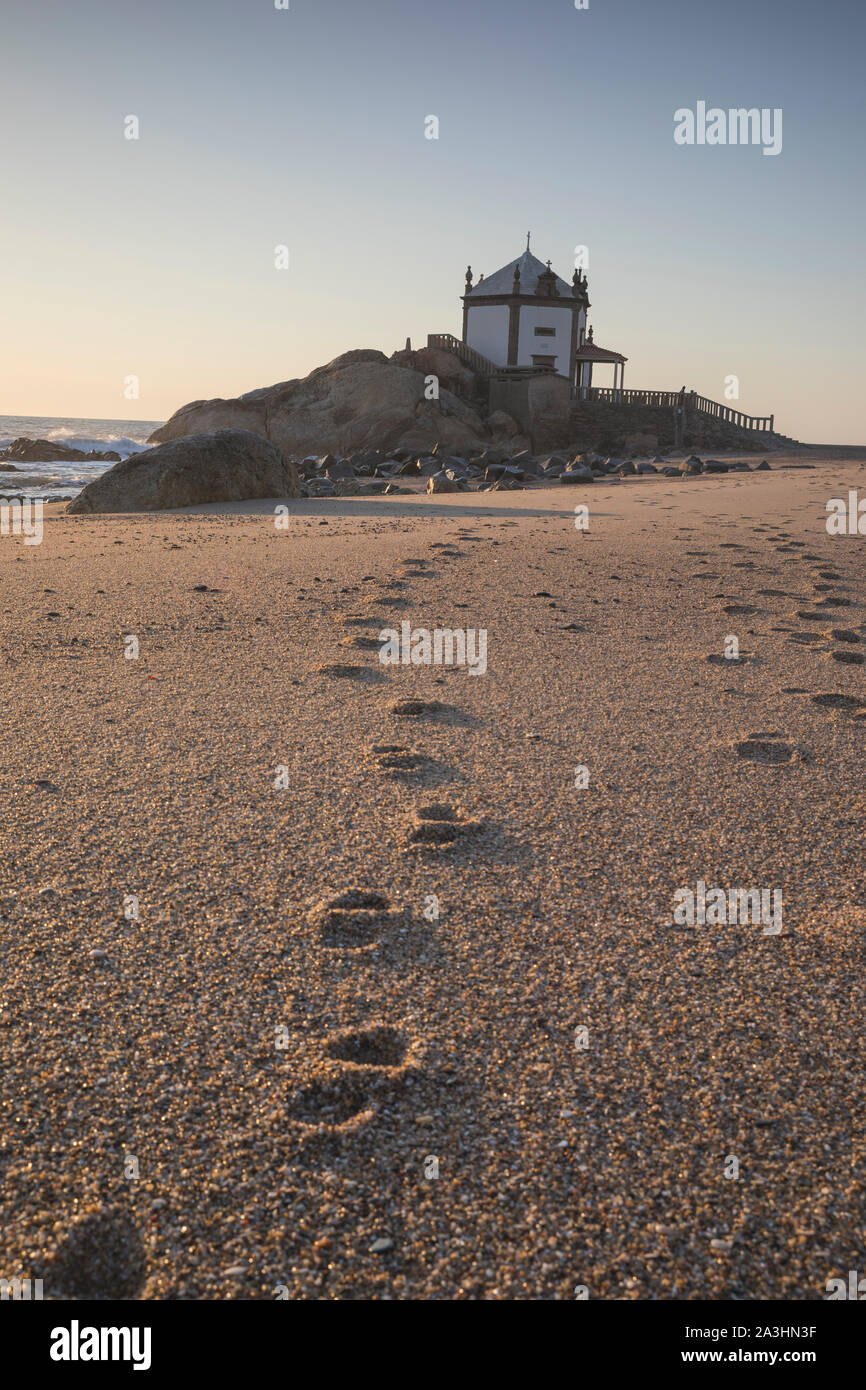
149,349,487,459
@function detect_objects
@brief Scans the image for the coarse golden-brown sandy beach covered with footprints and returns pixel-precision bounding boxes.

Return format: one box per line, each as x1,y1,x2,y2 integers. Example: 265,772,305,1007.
0,450,866,1300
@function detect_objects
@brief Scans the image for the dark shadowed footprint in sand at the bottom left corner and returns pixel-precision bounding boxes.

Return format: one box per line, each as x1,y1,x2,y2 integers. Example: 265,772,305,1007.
44,1207,146,1301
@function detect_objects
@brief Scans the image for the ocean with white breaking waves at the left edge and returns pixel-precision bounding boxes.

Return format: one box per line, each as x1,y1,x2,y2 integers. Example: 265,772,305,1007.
0,416,164,502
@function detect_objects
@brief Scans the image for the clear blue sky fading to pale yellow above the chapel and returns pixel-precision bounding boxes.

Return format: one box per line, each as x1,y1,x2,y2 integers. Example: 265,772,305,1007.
0,0,866,443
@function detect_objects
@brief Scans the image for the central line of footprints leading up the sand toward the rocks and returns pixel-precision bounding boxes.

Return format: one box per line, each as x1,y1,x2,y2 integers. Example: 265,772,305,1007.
294,542,482,1136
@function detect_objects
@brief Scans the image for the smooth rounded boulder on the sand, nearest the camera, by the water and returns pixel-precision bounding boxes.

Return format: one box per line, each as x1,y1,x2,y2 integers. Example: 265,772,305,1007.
67,430,302,514
